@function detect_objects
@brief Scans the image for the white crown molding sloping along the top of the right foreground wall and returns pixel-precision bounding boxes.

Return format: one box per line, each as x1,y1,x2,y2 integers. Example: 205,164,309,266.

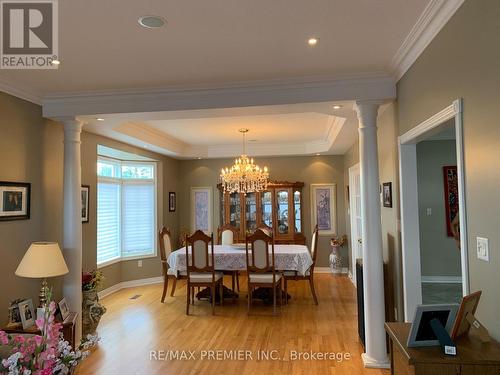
390,0,465,82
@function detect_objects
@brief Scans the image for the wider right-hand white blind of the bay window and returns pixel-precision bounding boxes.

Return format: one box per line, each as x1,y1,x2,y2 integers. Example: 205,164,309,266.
122,180,155,257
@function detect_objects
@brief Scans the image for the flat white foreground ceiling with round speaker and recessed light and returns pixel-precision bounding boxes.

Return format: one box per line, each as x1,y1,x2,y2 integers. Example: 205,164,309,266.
0,0,435,95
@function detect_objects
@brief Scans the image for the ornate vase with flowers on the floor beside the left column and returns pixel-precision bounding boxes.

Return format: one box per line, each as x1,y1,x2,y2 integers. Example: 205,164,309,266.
82,270,106,337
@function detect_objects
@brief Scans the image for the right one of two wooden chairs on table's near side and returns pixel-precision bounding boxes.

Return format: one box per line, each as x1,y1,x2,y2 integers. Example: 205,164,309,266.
245,229,282,314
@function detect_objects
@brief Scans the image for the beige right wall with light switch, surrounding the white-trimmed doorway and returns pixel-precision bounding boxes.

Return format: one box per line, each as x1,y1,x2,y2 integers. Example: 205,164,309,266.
397,0,500,339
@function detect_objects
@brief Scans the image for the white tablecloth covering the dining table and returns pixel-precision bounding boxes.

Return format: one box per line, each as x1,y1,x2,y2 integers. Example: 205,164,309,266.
167,245,312,275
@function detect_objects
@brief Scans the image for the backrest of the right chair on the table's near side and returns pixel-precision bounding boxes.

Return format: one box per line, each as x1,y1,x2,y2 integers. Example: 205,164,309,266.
246,229,275,272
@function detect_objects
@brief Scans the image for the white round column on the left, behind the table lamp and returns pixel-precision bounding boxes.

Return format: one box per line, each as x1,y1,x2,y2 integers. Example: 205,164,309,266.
61,118,82,345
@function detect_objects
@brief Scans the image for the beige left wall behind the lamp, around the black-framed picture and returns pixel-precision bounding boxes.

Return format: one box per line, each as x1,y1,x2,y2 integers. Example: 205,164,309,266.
0,93,60,324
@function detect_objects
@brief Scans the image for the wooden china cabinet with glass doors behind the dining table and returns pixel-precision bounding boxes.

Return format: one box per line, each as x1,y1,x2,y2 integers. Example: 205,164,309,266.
218,182,305,244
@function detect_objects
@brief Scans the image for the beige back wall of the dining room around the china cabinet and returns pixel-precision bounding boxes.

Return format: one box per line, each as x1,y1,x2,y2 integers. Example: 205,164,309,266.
178,156,347,267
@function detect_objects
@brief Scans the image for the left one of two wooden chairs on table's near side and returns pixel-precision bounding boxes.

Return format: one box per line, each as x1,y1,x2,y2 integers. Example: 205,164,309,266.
186,230,224,315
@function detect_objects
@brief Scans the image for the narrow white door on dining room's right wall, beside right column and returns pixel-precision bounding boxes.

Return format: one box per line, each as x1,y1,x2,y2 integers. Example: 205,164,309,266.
349,164,363,285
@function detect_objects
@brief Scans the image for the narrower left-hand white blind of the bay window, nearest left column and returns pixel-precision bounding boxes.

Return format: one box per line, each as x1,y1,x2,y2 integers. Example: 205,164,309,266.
97,182,121,264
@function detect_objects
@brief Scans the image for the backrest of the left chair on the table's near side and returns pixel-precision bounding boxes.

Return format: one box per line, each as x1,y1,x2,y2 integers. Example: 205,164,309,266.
186,230,214,274
